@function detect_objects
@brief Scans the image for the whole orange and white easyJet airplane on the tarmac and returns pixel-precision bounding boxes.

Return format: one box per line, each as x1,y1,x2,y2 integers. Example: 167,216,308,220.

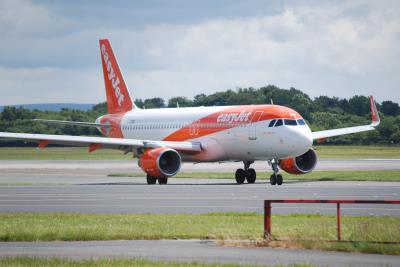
0,39,380,185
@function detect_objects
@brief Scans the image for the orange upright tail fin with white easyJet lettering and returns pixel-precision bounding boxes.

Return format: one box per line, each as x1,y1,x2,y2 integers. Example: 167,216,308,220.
99,39,137,114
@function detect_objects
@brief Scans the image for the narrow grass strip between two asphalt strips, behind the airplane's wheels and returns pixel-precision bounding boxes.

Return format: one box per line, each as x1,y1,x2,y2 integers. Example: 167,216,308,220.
109,170,400,182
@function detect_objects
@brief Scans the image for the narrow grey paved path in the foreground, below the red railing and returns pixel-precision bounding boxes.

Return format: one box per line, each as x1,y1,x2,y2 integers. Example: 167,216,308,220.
0,240,400,267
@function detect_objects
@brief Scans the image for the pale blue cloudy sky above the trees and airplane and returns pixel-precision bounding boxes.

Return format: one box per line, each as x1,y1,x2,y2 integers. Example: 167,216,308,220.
0,0,400,105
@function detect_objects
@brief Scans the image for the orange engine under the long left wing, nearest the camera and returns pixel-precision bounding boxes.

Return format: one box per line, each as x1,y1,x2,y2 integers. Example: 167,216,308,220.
139,147,181,177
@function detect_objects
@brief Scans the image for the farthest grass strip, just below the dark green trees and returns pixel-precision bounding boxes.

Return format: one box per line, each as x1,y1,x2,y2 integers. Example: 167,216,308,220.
0,145,400,160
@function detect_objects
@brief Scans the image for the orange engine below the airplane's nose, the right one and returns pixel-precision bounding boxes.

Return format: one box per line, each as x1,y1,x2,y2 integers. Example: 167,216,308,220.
279,149,317,174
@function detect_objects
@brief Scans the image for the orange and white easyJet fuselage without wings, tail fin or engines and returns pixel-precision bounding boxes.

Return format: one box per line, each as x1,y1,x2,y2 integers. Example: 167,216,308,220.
97,105,313,162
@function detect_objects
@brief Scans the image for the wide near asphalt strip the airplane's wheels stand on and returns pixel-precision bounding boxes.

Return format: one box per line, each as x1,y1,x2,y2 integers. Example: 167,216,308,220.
0,177,400,216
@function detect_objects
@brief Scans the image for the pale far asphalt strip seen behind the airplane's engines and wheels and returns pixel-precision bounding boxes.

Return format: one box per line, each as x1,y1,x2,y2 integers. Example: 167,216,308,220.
0,159,400,176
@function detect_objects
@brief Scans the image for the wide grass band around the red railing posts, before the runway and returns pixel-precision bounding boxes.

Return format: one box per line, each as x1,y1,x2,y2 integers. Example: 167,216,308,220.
0,213,400,255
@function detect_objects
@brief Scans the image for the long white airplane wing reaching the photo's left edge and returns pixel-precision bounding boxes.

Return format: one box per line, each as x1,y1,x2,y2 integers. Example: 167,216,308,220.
0,132,202,152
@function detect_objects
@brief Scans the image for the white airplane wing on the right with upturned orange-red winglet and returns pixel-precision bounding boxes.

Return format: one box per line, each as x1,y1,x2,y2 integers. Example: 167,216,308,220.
312,96,381,140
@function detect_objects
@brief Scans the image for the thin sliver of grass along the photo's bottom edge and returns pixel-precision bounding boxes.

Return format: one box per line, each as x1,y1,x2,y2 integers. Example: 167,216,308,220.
0,257,314,267
